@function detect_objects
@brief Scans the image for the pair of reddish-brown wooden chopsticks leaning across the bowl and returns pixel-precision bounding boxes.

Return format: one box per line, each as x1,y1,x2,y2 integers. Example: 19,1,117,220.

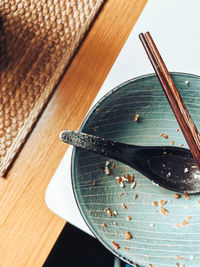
139,32,200,169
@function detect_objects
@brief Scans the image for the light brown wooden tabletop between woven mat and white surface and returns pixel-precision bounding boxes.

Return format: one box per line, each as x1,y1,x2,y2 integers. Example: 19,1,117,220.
0,0,147,267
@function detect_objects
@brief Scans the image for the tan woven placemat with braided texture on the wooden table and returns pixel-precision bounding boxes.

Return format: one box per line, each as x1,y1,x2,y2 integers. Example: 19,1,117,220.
0,0,105,176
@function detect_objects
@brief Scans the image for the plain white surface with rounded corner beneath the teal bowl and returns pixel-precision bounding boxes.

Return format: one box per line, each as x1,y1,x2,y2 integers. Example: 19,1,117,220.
45,0,200,235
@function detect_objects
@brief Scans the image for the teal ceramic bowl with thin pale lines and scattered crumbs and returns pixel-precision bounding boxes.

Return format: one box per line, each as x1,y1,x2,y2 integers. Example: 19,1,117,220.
71,73,200,267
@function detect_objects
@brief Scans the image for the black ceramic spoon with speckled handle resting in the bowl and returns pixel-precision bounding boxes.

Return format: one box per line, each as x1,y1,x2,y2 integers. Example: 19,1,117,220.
60,130,200,194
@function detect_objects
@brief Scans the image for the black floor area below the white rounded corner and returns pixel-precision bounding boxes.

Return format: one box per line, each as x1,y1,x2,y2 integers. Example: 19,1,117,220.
43,223,125,267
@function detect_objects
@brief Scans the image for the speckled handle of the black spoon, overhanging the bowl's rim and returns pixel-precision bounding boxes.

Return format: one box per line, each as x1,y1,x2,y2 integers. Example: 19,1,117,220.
60,130,137,165
